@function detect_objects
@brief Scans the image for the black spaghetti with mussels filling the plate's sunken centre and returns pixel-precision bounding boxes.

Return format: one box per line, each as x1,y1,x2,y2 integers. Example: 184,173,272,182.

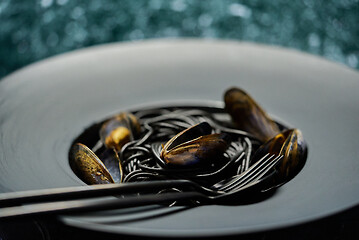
69,87,307,204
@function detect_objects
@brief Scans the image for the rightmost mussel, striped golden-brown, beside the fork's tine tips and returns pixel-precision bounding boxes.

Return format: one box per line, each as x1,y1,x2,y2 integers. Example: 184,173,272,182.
252,129,308,185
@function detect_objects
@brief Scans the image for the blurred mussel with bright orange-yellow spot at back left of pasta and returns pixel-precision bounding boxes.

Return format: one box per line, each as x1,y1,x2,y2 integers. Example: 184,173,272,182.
100,112,141,151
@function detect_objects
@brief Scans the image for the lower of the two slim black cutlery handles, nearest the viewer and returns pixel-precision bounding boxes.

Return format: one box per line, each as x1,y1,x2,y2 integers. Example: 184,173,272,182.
0,192,205,220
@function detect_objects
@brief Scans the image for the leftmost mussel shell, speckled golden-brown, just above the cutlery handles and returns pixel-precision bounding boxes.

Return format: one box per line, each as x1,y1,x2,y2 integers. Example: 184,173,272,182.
70,143,114,185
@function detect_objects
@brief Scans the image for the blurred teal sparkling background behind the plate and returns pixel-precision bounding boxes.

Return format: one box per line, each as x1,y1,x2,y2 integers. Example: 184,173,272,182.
0,0,359,78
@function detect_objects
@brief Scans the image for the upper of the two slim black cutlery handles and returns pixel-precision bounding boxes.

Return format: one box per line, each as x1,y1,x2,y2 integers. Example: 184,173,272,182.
0,180,194,207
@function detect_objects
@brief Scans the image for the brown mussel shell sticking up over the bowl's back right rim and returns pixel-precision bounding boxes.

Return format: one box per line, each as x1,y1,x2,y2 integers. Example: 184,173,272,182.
224,88,280,142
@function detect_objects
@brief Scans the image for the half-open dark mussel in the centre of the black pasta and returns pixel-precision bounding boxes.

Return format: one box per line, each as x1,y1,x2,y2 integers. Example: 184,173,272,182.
161,122,229,167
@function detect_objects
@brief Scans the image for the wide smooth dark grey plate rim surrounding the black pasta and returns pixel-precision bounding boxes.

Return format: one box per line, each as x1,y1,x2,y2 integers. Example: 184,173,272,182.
0,40,359,236
